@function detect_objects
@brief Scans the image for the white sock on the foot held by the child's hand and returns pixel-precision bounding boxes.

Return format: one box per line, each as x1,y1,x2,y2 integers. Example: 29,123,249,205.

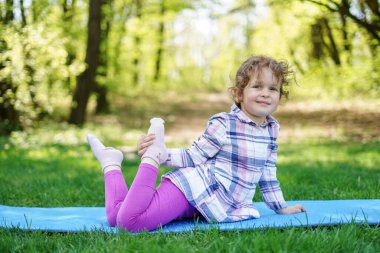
142,118,168,165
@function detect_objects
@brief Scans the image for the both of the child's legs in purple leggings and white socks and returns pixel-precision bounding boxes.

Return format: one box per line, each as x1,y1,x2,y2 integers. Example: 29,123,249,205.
88,119,196,231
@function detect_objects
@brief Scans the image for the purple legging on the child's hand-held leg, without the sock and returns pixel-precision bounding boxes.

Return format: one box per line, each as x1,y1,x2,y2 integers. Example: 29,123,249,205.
117,163,196,232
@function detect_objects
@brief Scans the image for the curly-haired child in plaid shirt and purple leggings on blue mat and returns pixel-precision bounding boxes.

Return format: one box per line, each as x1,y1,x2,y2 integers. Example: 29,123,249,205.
88,56,306,232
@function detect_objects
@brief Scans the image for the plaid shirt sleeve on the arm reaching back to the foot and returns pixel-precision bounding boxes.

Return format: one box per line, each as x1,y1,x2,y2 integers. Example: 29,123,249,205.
163,116,226,168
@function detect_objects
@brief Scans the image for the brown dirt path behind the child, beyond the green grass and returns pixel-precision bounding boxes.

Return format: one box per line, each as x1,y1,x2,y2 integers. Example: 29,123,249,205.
101,93,380,145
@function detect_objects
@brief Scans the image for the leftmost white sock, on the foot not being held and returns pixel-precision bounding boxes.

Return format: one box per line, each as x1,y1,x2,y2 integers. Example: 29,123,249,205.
87,134,124,173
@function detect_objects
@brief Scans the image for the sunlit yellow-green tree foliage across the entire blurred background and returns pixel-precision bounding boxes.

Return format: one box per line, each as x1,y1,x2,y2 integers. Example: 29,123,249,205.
0,0,380,132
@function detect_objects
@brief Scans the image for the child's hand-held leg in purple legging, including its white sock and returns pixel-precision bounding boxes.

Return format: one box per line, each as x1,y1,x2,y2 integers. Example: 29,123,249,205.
117,118,195,232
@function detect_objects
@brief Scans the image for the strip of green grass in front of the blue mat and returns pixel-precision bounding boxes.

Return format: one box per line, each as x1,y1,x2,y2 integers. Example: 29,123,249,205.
0,225,380,253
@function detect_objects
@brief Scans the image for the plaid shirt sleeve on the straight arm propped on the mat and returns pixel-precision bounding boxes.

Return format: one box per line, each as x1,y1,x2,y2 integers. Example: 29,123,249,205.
259,124,287,211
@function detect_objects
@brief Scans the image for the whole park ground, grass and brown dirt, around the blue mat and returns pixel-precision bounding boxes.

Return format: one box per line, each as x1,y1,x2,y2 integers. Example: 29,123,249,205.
0,94,380,253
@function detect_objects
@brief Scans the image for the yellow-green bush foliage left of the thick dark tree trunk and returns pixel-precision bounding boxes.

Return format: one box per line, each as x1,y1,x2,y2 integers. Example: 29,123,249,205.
0,19,84,127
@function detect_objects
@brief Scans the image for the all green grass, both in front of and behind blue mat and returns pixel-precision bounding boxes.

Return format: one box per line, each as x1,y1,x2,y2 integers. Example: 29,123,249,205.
0,129,380,252
